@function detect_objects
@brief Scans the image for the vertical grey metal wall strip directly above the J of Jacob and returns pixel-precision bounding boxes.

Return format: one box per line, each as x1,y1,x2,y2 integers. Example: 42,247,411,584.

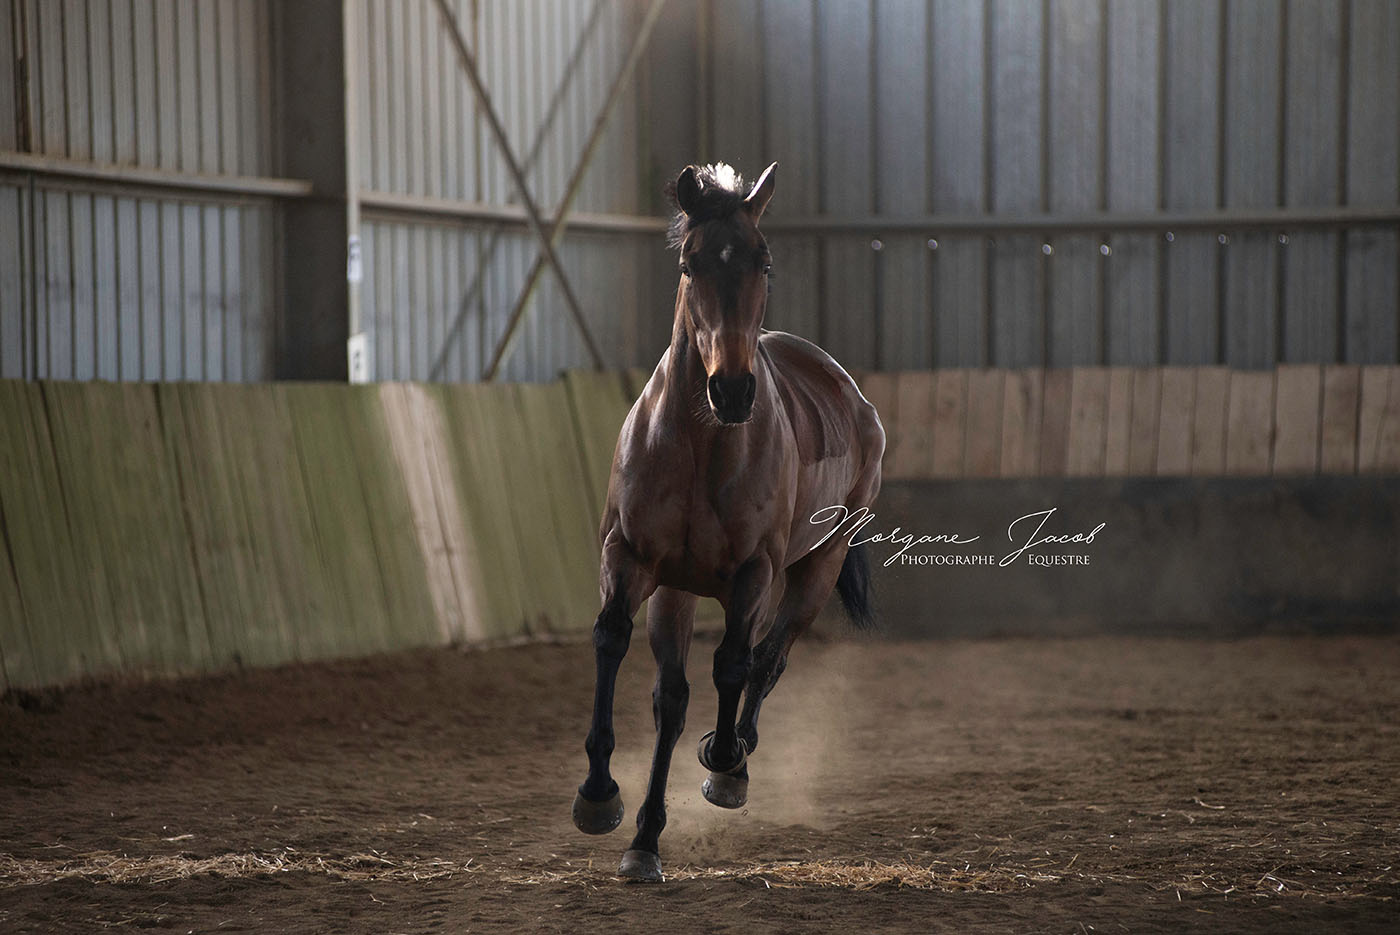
990,0,1063,369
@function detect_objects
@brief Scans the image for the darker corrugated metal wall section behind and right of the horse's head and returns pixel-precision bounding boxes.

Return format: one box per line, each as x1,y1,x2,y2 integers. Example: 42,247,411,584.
665,0,1400,370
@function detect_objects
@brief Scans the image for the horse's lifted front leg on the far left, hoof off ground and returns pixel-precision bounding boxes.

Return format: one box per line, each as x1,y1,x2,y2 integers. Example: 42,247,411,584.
573,536,655,834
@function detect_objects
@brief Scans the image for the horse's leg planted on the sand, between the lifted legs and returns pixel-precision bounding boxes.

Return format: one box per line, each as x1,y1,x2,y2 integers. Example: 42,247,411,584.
617,588,696,883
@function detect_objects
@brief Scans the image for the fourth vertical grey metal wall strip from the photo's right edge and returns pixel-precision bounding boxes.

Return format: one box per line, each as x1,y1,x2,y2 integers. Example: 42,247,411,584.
1162,0,1224,363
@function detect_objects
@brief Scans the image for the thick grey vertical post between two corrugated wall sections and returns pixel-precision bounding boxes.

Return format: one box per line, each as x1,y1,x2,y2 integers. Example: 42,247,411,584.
272,0,354,381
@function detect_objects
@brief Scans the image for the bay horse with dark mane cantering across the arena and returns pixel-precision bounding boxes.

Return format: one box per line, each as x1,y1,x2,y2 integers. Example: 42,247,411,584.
573,164,885,882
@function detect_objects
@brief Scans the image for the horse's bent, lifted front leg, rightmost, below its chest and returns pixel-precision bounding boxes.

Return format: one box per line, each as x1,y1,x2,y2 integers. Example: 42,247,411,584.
699,557,773,809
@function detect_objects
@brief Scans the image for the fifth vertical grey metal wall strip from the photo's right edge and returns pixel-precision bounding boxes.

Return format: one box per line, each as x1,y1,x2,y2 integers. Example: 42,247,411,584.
1105,3,1165,363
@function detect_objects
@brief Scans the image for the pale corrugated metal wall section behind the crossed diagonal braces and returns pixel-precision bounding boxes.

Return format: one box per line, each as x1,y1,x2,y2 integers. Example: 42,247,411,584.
353,0,657,381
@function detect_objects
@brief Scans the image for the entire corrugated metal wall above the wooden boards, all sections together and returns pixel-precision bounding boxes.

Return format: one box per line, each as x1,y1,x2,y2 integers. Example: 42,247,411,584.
0,0,1400,379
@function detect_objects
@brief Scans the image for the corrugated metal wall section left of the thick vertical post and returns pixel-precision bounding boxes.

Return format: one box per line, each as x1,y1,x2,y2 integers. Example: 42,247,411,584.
0,0,276,379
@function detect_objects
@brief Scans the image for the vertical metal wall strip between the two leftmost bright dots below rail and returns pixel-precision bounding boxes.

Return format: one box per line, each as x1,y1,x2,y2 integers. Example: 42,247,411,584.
874,0,934,370
